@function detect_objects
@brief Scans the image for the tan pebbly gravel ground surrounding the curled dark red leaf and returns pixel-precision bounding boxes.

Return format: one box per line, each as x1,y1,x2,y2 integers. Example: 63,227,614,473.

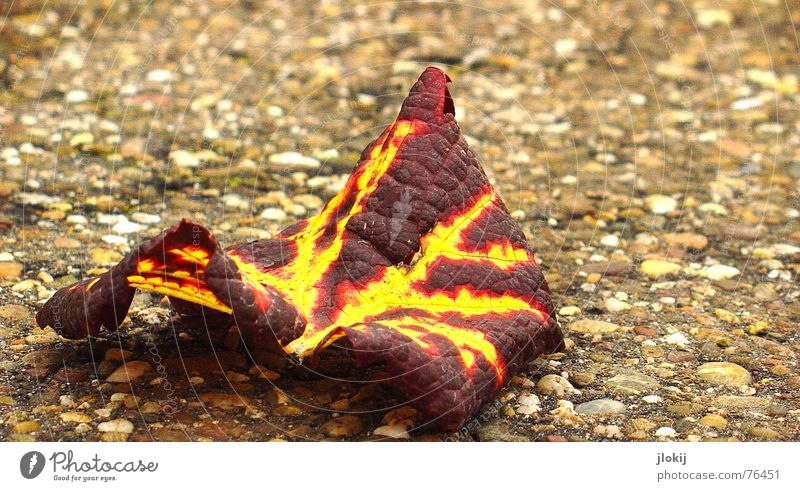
0,0,800,441
